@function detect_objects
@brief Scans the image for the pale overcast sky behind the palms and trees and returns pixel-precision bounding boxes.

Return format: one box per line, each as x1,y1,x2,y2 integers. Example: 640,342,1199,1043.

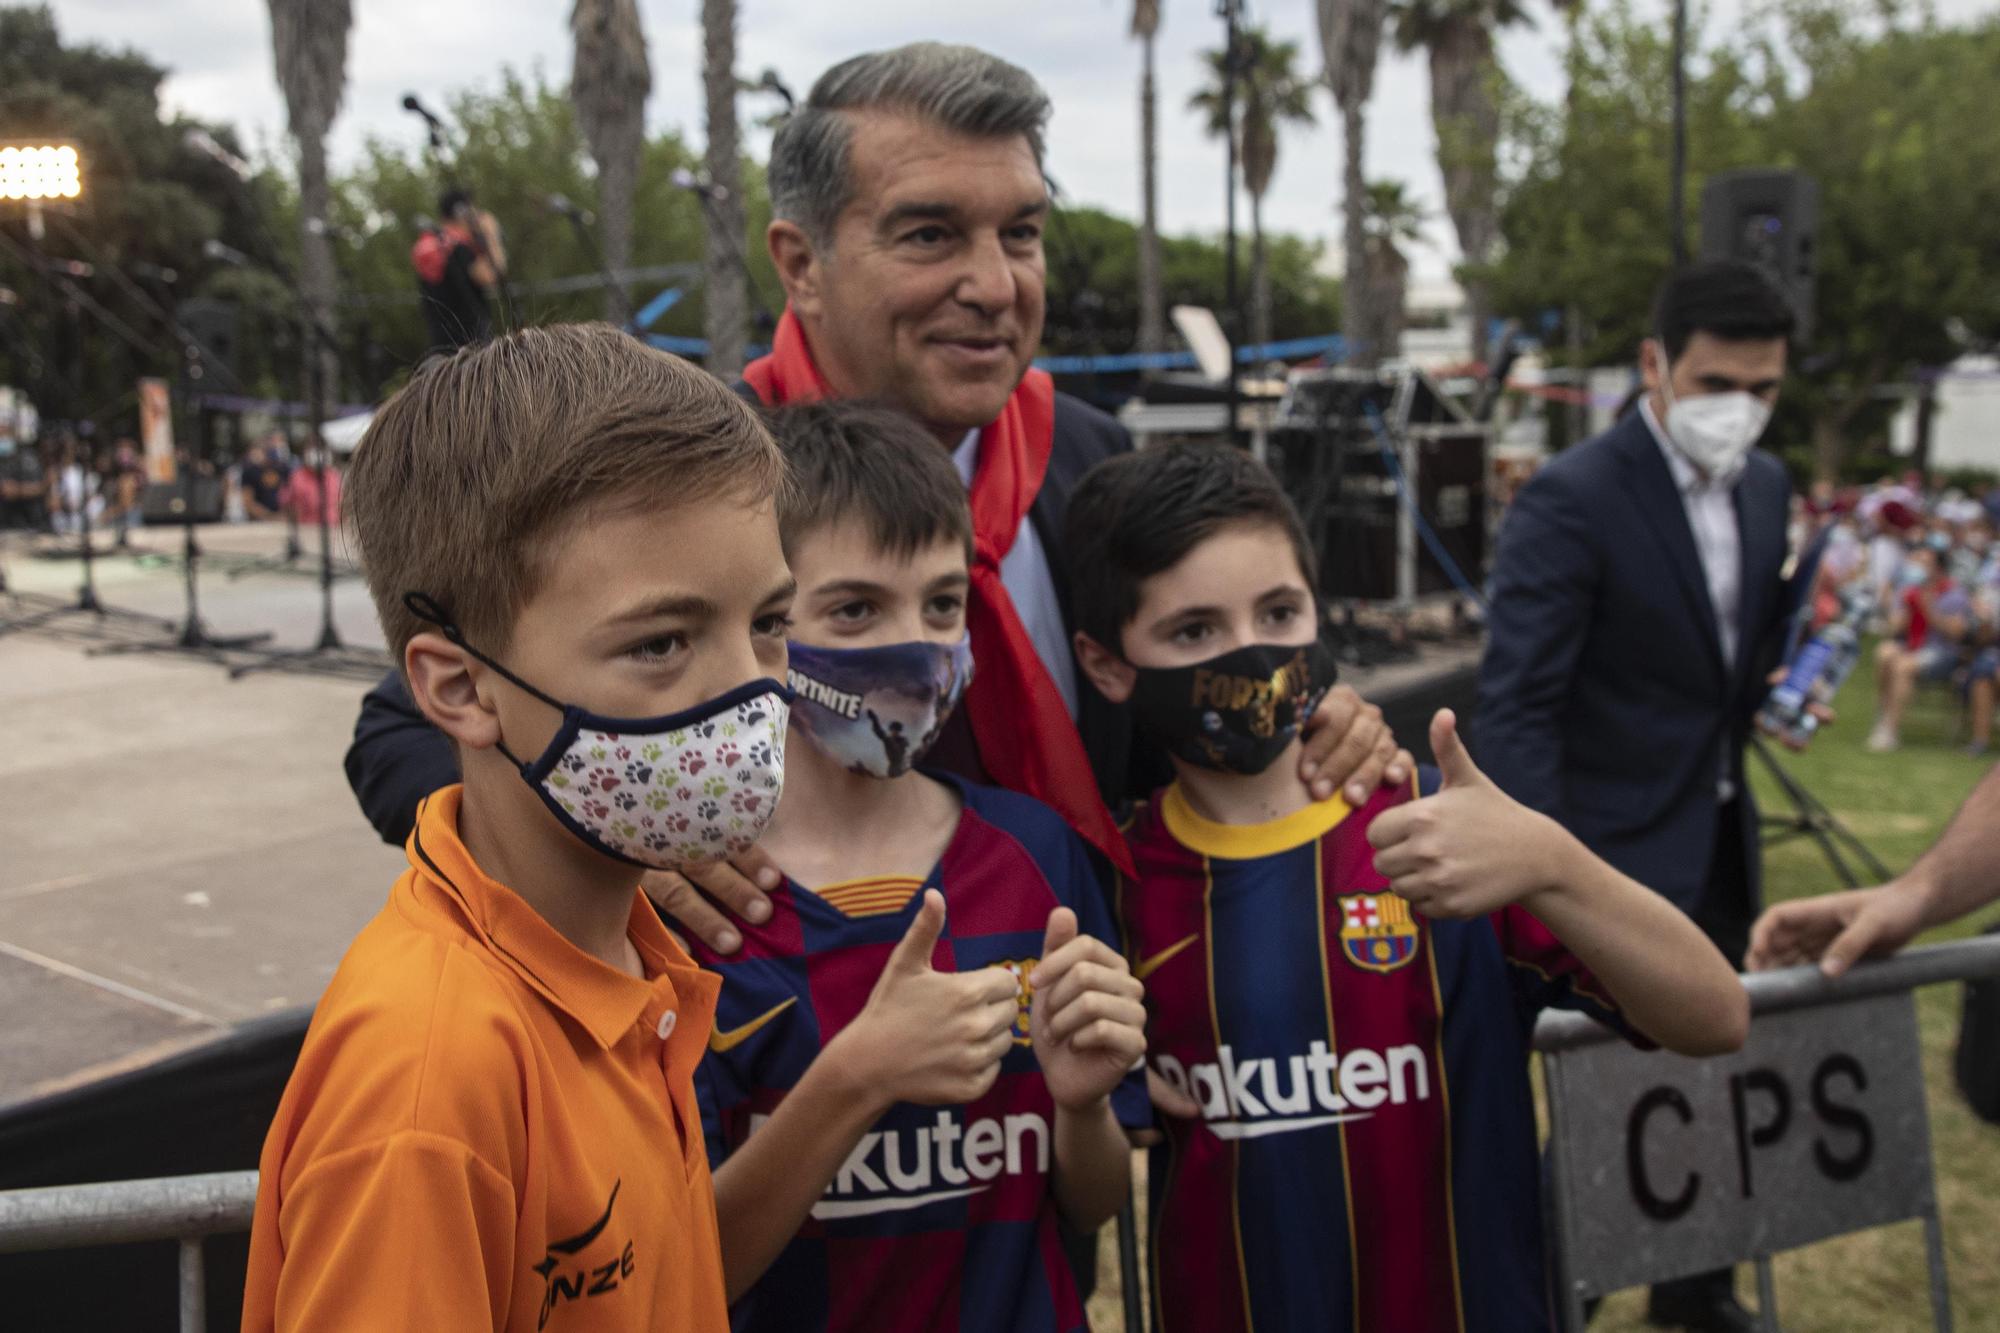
43,0,2000,276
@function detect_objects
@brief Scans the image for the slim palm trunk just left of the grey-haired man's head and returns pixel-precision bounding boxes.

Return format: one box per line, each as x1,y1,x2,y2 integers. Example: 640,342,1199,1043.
702,0,750,380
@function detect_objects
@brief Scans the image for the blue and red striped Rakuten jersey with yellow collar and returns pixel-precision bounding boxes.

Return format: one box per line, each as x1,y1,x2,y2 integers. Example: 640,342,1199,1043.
1118,772,1616,1333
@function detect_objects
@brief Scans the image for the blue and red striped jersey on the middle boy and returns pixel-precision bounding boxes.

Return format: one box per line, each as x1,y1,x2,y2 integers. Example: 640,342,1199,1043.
694,775,1152,1333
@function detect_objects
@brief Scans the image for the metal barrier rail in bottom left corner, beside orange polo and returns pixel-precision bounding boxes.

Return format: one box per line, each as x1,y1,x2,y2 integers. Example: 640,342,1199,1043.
0,1171,256,1333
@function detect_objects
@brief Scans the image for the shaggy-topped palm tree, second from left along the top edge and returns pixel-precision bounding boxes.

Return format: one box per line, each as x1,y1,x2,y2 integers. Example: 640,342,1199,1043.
570,0,652,324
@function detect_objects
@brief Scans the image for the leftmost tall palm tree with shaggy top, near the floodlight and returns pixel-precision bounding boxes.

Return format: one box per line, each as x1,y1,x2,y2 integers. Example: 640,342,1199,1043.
268,0,354,420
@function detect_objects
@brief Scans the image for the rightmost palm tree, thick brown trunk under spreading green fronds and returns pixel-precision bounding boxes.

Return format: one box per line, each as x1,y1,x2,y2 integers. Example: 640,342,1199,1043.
1392,0,1528,358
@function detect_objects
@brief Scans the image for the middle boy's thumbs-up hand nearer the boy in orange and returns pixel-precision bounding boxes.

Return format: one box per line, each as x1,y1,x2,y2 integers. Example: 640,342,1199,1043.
828,889,1020,1109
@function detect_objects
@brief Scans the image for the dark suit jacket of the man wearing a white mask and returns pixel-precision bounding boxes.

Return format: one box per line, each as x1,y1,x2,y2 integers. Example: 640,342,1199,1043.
1476,412,1790,913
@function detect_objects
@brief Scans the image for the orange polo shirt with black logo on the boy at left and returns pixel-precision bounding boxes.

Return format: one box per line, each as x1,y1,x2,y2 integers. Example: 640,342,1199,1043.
244,787,728,1333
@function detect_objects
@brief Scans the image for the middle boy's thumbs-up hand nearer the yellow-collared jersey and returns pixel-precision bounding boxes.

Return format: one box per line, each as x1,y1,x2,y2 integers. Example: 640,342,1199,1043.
1028,907,1146,1111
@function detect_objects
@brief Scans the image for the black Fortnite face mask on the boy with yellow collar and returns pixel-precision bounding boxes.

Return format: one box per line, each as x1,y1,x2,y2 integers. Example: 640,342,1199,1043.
1132,640,1340,775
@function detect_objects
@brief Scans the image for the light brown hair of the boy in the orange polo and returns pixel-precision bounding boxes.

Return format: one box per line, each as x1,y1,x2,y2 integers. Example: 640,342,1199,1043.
346,324,784,662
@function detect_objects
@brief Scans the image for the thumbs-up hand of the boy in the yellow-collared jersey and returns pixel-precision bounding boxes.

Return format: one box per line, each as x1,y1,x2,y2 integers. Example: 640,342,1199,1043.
1368,709,1576,919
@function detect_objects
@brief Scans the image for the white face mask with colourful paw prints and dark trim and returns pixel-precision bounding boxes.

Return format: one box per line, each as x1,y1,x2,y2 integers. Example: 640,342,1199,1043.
404,592,792,871
